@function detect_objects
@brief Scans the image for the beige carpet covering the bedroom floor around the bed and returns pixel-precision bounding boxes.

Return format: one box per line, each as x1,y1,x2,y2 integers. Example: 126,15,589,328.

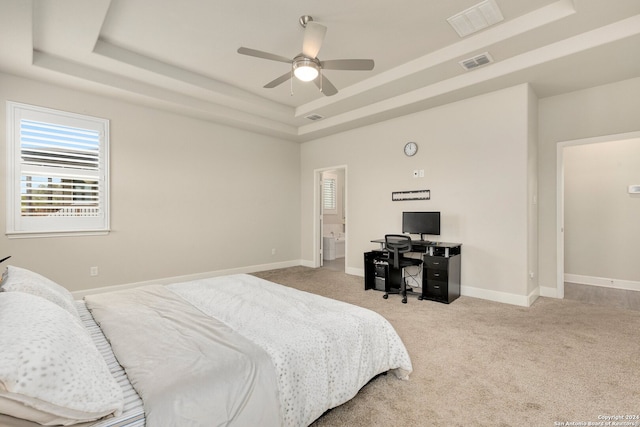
256,267,640,427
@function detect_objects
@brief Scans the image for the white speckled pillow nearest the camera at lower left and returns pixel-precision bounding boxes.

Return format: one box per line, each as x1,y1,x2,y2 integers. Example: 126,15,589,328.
0,292,124,425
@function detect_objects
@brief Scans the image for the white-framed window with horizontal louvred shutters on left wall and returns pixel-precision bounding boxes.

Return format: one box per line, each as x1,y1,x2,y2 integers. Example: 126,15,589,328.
7,102,109,237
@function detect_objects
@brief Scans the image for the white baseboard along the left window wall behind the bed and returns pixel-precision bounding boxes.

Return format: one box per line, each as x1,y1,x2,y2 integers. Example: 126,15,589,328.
71,260,302,299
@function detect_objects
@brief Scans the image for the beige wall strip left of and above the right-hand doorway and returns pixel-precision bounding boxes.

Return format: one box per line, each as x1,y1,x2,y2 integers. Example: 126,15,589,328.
538,78,640,296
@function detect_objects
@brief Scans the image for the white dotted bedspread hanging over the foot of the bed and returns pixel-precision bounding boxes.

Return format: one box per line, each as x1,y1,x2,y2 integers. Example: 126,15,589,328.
168,274,412,426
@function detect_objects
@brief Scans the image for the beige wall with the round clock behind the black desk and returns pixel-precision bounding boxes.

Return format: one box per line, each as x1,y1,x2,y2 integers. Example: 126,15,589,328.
301,85,536,305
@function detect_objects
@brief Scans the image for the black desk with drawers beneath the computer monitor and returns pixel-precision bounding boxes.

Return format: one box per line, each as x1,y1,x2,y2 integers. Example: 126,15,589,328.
364,239,462,304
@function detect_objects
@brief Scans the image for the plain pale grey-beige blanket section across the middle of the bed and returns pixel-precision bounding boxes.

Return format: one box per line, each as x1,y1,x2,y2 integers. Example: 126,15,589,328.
85,285,282,427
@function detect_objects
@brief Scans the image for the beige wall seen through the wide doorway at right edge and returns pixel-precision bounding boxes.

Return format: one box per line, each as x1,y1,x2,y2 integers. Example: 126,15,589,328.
564,139,640,290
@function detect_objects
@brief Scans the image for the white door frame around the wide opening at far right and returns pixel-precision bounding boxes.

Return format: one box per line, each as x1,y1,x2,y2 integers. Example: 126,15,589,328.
556,132,640,299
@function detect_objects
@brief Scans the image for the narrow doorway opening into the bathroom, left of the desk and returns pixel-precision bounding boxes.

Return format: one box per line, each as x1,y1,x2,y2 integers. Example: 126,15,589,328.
315,166,348,272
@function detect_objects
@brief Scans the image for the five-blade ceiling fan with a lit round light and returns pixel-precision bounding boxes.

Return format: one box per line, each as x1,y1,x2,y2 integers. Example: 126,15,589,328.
238,15,374,96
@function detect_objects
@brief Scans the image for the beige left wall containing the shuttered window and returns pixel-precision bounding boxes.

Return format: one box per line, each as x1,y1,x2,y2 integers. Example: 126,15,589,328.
0,74,300,290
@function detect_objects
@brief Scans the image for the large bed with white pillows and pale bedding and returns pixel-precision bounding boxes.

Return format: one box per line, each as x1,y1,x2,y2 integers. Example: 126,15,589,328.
0,266,412,427
